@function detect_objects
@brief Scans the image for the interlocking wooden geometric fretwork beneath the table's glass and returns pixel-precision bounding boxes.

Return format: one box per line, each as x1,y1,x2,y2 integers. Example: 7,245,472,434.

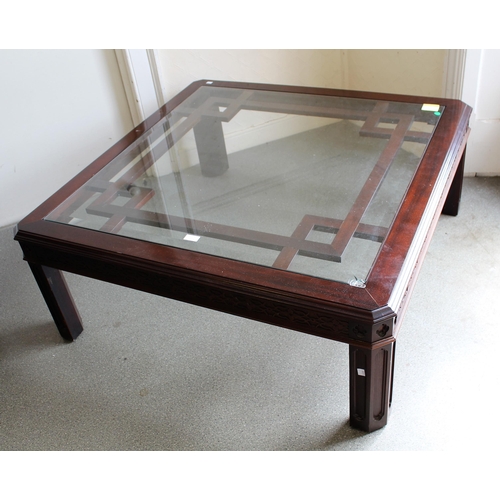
51,94,436,269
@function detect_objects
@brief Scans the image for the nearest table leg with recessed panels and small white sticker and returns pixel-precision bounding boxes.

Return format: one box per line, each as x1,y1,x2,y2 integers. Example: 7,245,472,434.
349,343,394,432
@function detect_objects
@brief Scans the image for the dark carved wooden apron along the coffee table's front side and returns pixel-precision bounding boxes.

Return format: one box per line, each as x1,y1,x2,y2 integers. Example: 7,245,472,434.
19,238,395,349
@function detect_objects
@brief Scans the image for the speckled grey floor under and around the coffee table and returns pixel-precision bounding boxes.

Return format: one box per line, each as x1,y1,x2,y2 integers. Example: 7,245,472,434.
0,178,500,453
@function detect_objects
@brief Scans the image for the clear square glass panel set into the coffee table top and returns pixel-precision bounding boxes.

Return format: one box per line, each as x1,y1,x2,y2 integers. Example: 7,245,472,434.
45,82,444,287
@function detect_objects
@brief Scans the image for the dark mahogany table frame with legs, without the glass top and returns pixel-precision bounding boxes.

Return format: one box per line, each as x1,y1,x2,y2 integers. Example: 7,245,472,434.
15,81,471,431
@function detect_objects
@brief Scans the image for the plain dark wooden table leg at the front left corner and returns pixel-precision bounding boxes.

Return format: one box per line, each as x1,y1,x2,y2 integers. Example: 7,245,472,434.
29,262,83,341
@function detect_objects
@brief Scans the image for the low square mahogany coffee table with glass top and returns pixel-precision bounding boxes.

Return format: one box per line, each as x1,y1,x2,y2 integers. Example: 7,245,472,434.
15,80,471,431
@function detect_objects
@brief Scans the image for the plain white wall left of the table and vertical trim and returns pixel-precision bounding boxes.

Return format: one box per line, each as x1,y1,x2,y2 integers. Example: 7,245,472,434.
0,50,133,227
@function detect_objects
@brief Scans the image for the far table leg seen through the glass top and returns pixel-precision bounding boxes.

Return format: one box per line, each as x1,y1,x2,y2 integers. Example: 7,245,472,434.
193,117,229,177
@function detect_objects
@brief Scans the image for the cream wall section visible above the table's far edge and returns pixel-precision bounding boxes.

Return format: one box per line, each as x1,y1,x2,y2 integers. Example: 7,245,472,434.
158,49,448,98
